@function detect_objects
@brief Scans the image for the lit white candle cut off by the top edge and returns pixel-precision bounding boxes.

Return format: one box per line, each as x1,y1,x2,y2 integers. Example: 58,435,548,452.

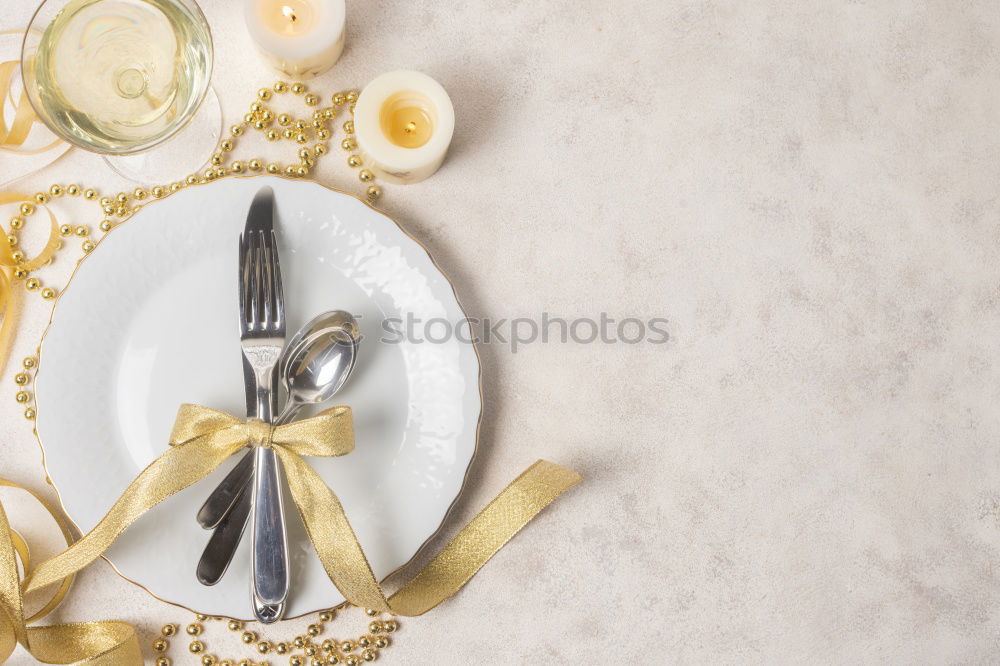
243,0,347,78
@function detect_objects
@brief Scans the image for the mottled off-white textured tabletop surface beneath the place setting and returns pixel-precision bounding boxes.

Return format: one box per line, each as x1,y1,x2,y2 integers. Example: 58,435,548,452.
0,0,1000,664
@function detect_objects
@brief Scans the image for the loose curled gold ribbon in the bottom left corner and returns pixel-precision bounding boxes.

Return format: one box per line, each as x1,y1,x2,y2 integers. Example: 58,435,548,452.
0,479,142,666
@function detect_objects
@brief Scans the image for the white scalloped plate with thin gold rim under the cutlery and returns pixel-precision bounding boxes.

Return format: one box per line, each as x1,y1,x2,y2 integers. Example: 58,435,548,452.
36,177,481,618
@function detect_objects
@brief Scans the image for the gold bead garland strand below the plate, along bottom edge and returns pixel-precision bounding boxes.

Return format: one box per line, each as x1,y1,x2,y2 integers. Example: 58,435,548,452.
152,604,399,666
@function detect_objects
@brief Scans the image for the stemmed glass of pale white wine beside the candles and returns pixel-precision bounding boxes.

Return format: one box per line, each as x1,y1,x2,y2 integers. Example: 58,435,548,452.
21,0,222,183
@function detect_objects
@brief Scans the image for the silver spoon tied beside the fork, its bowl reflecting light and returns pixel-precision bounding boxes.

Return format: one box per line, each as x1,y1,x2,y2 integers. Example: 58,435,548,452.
197,311,359,588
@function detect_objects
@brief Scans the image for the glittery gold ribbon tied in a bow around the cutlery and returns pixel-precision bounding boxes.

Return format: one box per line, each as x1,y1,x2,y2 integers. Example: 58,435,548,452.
13,405,581,615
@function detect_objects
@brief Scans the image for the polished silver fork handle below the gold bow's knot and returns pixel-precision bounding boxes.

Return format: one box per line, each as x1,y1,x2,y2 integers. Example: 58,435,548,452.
252,447,289,604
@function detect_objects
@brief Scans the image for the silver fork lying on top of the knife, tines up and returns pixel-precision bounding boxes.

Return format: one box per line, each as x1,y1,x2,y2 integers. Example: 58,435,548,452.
239,219,289,622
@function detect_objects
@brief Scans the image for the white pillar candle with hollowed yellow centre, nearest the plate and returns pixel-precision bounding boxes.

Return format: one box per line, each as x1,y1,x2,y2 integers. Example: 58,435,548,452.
354,71,455,183
